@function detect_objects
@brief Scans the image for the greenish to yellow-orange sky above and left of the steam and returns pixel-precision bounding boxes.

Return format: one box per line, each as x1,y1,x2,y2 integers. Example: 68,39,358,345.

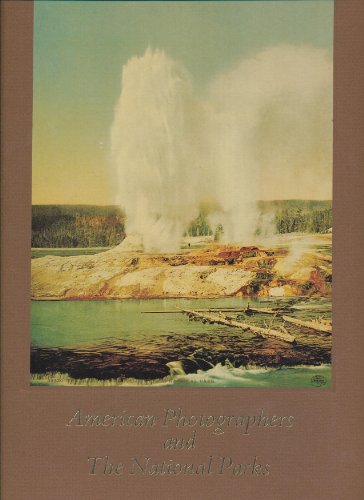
33,1,333,205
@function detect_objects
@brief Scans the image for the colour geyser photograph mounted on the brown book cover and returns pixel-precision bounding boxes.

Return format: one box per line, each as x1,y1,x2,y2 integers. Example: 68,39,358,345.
30,0,334,389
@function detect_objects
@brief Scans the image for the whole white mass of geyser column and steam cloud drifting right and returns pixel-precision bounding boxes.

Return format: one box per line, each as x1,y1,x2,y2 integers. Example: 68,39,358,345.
111,46,332,251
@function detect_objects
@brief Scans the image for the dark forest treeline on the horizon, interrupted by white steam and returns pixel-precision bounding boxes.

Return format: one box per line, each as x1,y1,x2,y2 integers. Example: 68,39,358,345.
32,200,332,248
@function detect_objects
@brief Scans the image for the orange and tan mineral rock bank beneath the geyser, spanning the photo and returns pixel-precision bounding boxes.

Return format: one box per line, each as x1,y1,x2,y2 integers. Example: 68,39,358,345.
32,245,331,300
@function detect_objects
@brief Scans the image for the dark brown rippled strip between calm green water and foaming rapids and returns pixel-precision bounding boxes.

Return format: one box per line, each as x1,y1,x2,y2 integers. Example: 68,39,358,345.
31,322,331,380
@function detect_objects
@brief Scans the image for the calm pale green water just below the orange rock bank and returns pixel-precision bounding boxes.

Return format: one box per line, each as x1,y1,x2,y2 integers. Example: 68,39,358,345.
31,298,259,347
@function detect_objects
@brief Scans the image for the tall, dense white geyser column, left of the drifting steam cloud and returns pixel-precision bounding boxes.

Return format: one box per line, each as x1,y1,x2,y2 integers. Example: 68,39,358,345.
112,49,201,251
